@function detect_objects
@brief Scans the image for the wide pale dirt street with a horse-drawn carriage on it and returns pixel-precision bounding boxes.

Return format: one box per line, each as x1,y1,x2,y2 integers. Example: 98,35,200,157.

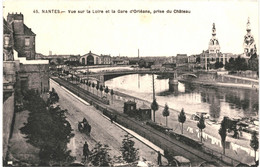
50,81,167,164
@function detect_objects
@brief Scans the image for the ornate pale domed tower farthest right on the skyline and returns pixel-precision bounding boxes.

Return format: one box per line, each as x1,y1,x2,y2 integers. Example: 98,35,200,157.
243,18,256,57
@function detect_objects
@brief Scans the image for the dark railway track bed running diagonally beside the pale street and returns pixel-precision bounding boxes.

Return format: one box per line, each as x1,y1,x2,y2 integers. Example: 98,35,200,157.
52,77,242,166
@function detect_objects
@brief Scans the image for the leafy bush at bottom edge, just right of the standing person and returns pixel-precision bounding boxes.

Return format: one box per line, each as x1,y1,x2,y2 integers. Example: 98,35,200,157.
89,142,111,166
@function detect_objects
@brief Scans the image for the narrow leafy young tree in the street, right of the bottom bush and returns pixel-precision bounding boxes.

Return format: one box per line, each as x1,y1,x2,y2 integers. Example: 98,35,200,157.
120,134,139,163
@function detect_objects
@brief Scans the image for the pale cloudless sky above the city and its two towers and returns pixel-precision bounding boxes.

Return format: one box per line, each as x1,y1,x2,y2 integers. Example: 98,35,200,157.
3,0,259,57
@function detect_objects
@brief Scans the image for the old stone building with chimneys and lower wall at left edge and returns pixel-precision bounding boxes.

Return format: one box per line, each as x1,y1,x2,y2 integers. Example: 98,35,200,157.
3,14,49,161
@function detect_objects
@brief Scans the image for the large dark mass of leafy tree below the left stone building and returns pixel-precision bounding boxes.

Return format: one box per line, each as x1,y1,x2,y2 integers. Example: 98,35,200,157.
20,91,74,165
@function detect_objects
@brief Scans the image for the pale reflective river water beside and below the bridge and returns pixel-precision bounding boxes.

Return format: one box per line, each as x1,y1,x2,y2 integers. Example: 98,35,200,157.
105,74,258,121
